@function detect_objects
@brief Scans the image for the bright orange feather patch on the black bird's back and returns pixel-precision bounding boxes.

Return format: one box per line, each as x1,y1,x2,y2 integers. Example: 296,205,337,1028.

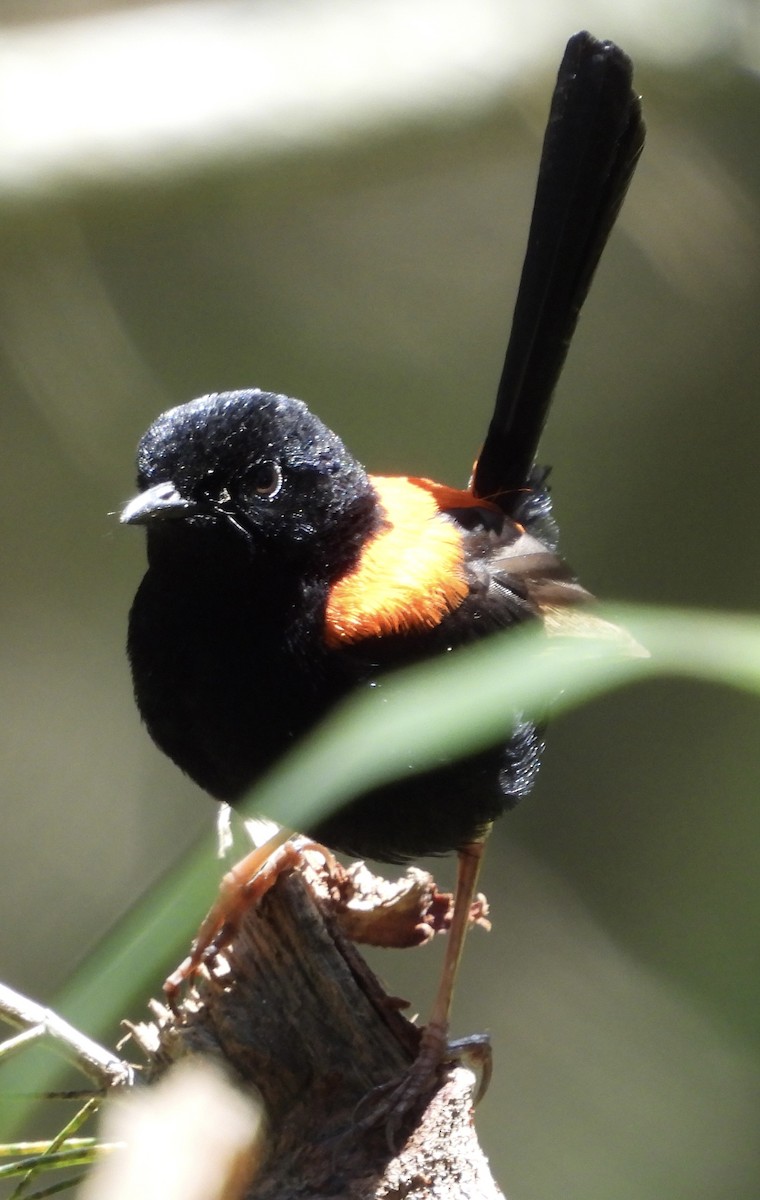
324,475,483,646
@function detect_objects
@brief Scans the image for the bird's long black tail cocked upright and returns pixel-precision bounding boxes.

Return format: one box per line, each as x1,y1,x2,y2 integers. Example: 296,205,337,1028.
472,32,645,512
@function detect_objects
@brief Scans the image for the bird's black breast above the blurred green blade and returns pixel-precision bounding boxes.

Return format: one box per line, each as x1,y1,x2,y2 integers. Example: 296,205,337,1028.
127,540,345,803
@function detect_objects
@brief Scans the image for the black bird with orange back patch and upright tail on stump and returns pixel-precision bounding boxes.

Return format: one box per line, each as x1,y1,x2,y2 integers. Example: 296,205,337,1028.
121,32,644,1099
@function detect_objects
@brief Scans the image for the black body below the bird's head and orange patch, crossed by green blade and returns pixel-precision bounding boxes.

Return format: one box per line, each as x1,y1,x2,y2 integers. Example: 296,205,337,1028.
128,506,540,862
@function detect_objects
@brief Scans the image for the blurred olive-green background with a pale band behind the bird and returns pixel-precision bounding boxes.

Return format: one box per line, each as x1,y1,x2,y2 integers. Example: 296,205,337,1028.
0,0,760,1200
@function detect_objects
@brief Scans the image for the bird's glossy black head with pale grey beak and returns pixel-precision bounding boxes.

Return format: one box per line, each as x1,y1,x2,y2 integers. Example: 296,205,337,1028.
121,389,379,571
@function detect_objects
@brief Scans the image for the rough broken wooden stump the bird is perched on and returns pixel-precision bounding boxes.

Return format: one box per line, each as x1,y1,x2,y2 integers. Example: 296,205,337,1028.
127,864,501,1200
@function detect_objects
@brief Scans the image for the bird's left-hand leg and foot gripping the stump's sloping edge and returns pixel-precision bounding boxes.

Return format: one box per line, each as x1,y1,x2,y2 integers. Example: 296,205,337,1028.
163,829,333,1010
